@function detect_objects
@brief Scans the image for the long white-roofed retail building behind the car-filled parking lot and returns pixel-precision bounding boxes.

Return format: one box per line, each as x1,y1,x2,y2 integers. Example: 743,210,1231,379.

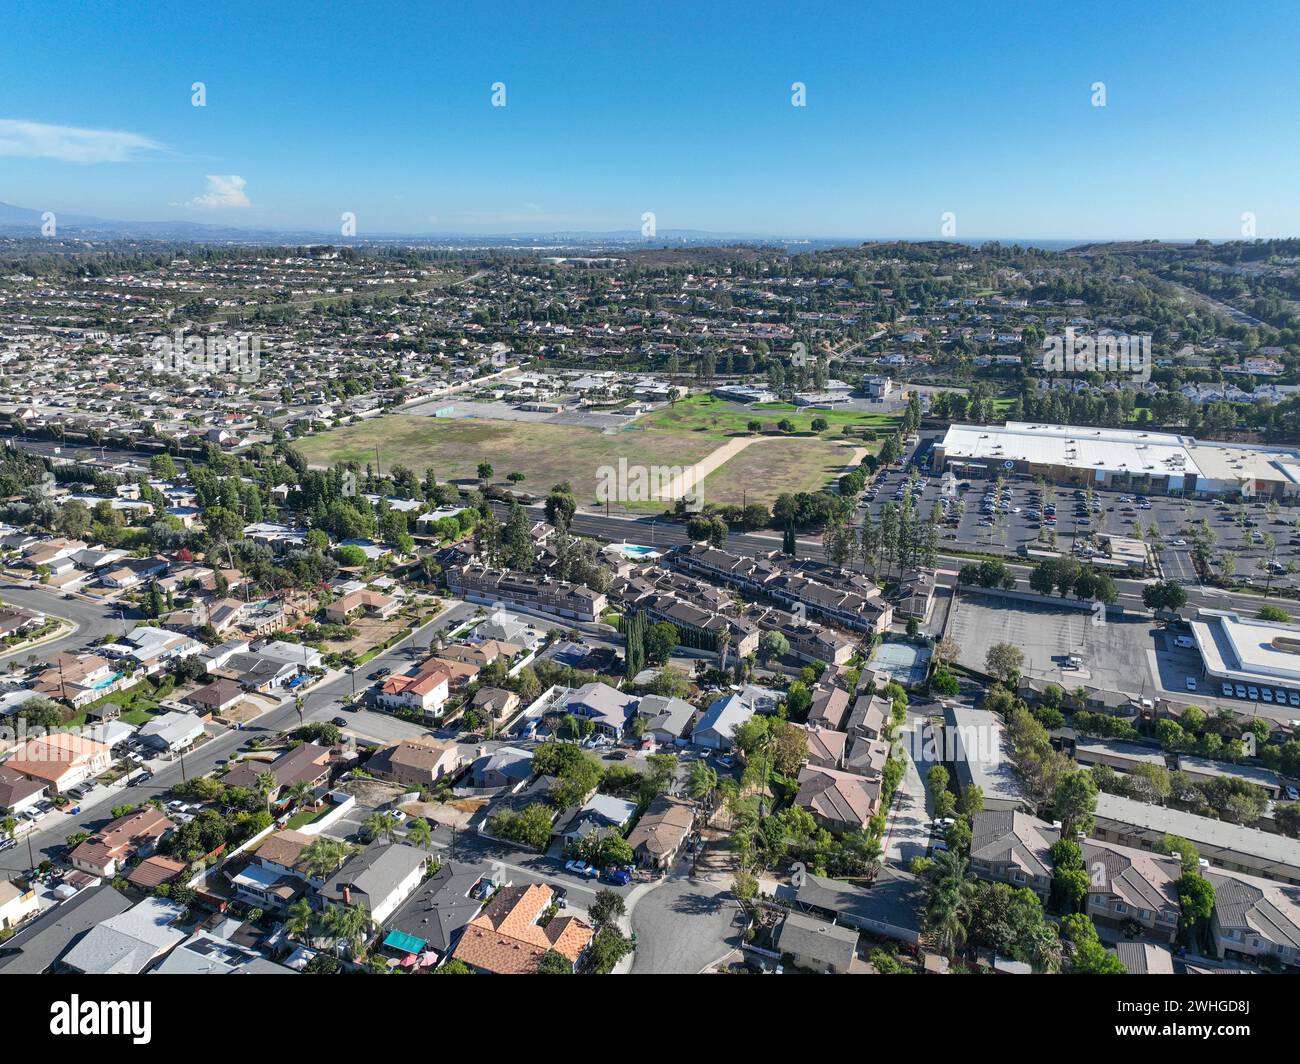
932,421,1300,497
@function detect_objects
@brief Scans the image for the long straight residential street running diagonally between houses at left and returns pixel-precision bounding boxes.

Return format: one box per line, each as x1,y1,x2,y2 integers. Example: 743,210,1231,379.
0,592,478,871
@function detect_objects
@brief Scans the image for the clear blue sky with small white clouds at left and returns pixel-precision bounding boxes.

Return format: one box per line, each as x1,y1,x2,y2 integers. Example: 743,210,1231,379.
0,0,1300,239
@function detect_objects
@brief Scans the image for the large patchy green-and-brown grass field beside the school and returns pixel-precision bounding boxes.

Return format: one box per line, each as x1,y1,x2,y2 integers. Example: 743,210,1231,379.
295,395,898,511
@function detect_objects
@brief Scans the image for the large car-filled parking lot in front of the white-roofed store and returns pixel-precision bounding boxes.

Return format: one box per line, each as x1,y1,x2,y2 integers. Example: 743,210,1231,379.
865,433,1300,588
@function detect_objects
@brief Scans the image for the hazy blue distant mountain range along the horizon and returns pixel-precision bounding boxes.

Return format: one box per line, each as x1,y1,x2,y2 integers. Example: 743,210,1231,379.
0,202,1138,250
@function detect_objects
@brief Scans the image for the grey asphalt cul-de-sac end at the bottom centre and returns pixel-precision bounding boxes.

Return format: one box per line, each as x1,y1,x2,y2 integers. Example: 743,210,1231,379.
631,865,741,976
